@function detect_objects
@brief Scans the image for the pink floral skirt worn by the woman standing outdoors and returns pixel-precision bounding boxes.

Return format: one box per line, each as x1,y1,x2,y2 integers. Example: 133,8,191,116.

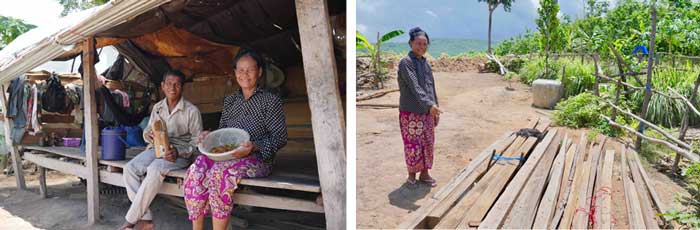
399,111,435,173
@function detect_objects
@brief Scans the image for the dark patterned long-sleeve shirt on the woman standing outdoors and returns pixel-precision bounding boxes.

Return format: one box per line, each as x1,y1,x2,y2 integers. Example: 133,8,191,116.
398,51,438,114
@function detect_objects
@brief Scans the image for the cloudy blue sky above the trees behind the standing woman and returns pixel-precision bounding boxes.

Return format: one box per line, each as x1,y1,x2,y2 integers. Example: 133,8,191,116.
357,0,614,41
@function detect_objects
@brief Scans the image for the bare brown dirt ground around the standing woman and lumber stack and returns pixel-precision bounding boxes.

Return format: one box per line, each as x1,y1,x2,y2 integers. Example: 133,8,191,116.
357,70,688,229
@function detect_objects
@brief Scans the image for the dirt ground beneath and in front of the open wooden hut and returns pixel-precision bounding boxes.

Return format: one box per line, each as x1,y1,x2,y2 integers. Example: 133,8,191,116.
0,169,325,229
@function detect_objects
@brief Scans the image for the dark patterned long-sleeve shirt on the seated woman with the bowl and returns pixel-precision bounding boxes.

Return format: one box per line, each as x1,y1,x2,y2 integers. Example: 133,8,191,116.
219,88,287,164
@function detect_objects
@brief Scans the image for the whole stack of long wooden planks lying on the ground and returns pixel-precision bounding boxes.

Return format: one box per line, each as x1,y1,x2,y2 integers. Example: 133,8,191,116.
398,120,665,229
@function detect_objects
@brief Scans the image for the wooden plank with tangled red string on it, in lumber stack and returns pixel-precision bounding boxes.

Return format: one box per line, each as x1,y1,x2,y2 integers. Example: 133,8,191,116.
593,150,615,229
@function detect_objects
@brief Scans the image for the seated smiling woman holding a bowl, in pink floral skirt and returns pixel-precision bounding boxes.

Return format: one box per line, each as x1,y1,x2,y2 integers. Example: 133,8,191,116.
184,49,287,230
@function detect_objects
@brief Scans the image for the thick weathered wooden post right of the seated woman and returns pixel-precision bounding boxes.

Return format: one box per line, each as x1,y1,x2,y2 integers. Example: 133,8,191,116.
296,0,346,229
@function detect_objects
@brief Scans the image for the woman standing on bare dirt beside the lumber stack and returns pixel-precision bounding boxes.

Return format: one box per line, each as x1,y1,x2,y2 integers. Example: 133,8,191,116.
398,27,442,187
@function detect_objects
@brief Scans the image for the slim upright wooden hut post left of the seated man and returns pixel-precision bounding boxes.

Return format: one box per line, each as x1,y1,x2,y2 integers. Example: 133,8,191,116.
82,36,100,224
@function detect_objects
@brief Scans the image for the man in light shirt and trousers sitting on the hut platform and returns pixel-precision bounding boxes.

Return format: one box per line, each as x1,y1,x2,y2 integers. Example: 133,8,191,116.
121,70,202,229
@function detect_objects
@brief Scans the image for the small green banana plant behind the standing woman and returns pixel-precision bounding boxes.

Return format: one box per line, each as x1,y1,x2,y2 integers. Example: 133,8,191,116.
355,30,404,86
